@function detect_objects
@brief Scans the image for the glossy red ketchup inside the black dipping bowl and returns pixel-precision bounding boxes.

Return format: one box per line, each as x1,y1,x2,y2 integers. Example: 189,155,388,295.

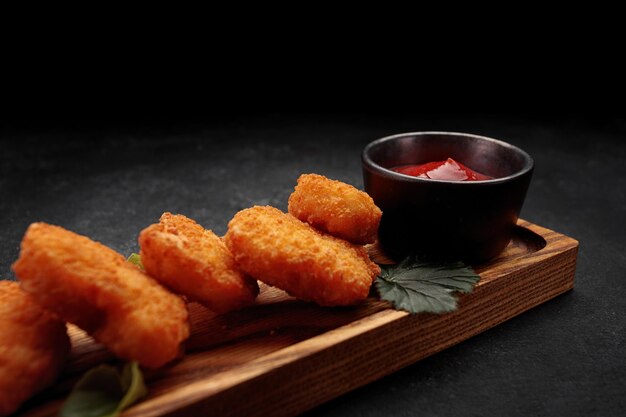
391,158,493,181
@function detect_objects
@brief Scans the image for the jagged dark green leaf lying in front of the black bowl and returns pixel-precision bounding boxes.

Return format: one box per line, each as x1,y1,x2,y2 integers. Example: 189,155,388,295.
375,256,480,314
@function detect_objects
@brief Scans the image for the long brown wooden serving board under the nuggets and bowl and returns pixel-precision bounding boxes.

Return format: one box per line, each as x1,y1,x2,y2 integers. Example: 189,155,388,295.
21,221,578,417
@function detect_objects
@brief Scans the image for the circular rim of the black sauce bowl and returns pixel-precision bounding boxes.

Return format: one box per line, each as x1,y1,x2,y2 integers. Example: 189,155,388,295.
361,131,535,183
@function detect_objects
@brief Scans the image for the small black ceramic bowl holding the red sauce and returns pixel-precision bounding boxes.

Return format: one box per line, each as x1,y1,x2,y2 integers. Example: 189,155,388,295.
362,132,534,264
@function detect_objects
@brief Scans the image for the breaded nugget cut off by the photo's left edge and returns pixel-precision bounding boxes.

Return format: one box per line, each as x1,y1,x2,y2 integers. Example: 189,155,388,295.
0,281,70,416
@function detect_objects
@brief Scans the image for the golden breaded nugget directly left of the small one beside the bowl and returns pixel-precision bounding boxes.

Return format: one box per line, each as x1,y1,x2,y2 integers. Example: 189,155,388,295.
225,206,380,306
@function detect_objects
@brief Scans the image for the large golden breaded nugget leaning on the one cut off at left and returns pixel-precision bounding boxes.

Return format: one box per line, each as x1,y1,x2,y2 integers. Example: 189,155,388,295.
13,223,189,368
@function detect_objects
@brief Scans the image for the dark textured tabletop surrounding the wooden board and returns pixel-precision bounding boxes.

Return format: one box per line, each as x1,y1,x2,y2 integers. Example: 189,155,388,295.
0,112,626,417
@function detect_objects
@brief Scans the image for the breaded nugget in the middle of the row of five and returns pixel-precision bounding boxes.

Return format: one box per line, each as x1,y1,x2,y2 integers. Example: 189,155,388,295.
139,213,259,313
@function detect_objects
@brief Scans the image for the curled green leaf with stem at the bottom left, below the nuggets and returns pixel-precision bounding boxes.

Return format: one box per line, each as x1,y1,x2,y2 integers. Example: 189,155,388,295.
59,362,148,417
